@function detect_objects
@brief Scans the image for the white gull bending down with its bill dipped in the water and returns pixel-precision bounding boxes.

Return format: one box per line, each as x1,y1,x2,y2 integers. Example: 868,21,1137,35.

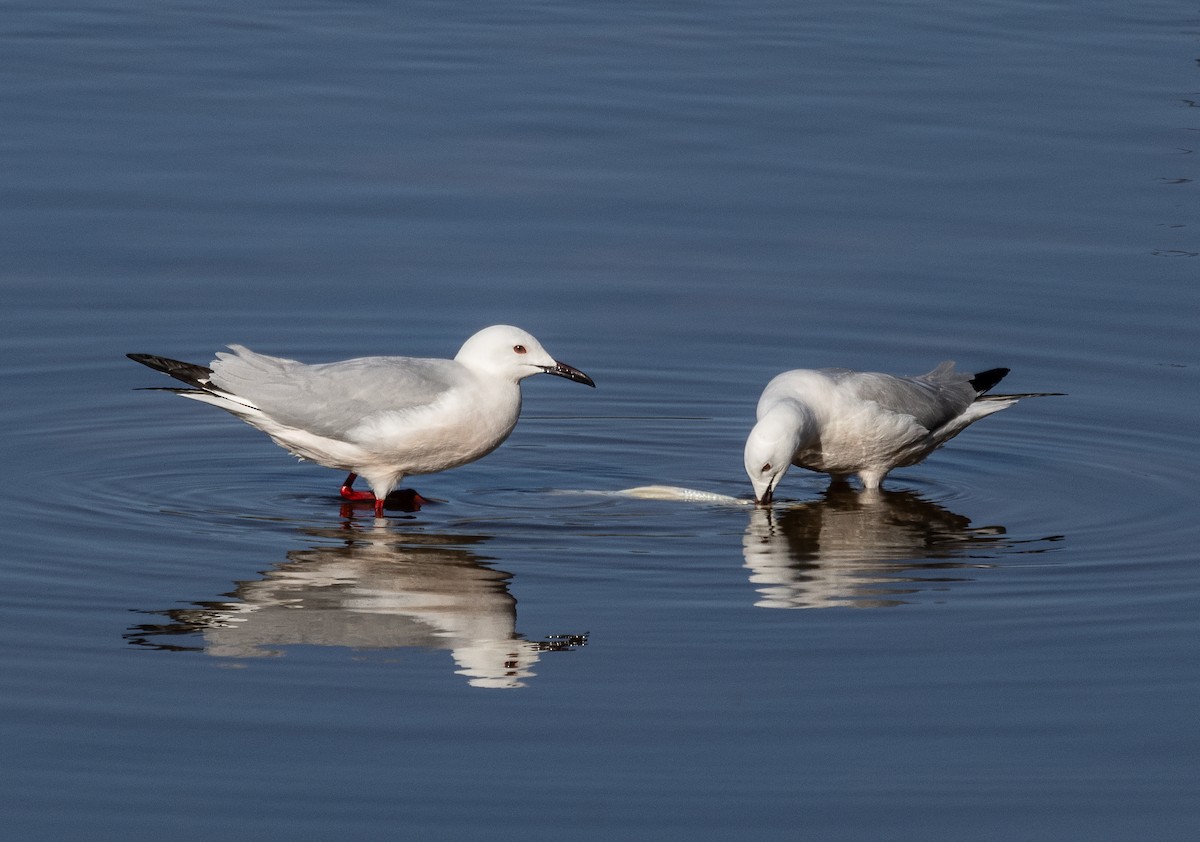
745,361,1058,504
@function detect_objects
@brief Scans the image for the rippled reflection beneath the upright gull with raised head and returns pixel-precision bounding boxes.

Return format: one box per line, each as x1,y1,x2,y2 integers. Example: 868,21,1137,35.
126,529,587,687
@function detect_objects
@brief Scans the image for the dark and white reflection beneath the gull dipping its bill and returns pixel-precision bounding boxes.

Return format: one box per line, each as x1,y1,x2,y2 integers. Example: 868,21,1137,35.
743,485,1061,608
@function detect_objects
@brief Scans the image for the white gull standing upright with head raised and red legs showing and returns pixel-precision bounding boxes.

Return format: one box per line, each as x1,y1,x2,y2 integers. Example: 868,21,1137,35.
127,325,595,517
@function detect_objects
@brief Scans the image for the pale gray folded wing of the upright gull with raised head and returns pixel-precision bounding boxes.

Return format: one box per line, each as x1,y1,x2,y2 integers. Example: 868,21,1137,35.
211,345,469,438
